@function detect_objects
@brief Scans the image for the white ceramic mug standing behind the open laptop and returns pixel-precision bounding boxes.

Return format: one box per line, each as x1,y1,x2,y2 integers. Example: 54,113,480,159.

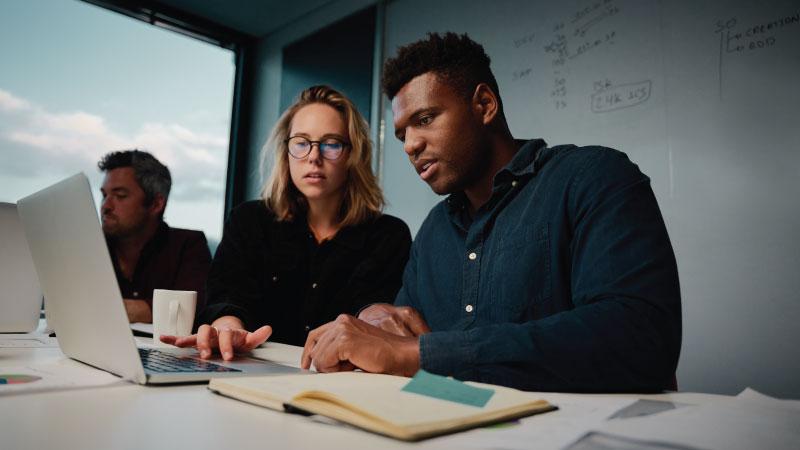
153,289,197,345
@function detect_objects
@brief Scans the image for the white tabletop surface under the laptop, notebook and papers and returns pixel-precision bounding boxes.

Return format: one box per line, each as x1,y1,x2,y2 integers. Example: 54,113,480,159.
0,343,764,450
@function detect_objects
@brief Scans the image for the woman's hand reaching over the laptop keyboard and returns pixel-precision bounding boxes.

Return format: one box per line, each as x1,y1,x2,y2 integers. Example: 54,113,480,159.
159,316,272,361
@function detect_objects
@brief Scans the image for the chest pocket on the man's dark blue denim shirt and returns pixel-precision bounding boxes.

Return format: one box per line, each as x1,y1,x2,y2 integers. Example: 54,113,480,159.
490,224,552,322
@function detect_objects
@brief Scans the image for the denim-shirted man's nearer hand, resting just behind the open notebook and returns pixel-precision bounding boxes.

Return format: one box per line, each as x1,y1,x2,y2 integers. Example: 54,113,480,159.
300,314,419,376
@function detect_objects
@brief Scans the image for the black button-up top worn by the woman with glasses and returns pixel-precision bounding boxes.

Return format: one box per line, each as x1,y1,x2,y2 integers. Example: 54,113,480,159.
199,200,411,345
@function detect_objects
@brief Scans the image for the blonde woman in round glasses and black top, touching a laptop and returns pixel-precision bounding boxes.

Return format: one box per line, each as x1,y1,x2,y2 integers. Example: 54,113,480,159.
161,86,411,359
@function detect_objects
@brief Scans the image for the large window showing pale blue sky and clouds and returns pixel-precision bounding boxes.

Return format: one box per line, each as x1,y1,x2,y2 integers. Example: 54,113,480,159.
0,0,235,249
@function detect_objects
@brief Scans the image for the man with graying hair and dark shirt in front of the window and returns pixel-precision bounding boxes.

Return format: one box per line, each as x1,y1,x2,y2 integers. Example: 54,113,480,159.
97,150,211,323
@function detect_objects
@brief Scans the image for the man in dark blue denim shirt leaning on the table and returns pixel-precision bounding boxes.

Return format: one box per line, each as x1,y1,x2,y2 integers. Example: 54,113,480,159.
302,33,681,392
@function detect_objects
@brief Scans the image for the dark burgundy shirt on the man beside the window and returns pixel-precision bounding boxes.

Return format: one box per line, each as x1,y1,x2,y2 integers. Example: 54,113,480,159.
107,222,211,311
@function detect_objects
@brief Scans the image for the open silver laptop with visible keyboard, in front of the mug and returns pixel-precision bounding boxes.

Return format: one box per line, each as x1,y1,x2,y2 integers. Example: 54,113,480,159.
17,173,301,384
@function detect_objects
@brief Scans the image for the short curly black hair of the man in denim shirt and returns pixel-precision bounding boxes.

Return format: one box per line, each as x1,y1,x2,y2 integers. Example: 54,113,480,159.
381,32,500,105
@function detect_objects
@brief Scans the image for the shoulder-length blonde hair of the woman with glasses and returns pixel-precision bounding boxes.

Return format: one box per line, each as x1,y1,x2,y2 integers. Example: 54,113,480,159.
261,86,384,227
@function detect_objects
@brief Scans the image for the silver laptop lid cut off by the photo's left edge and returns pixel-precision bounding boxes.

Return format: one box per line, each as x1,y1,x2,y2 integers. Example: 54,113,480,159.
0,203,42,333
